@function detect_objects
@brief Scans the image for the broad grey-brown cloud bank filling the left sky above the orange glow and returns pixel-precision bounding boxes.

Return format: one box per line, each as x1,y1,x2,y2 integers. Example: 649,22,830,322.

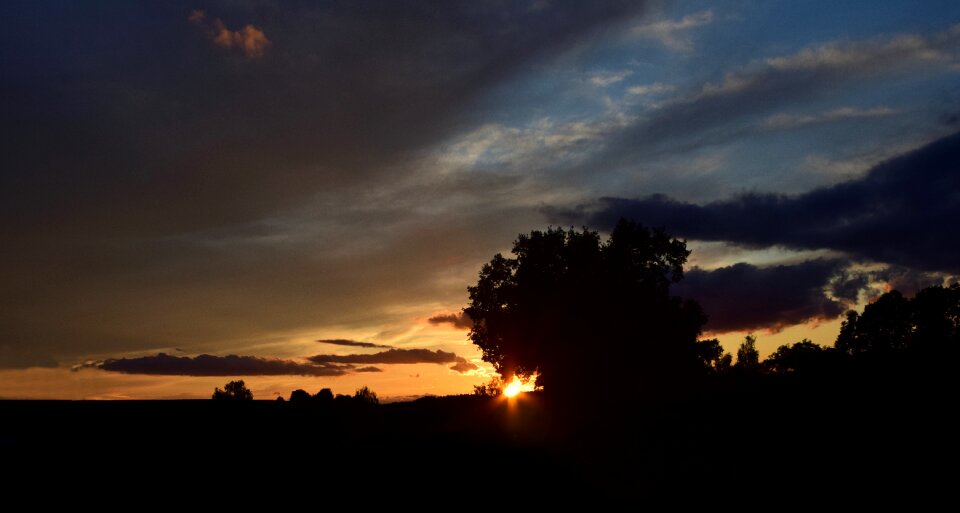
0,0,641,368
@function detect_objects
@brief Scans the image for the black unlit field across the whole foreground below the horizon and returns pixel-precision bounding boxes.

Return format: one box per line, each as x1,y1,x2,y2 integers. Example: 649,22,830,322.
0,376,958,506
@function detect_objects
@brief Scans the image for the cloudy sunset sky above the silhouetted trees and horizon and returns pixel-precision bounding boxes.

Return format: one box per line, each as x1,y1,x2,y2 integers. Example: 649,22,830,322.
0,0,960,399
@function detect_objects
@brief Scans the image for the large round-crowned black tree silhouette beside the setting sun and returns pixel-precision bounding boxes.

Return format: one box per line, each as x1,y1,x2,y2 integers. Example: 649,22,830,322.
464,220,706,393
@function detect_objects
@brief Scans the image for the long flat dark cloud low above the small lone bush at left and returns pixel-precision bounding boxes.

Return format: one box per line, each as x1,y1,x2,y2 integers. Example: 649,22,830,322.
92,353,351,376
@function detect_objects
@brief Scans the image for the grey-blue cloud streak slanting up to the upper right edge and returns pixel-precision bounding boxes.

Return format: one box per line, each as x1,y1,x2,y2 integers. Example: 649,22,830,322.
596,25,960,167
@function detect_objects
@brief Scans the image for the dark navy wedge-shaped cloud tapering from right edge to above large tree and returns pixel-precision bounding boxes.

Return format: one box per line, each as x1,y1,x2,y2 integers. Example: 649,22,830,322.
551,133,960,272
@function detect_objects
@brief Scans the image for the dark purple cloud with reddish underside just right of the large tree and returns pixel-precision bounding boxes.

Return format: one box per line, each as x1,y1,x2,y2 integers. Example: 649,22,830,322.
673,260,848,333
